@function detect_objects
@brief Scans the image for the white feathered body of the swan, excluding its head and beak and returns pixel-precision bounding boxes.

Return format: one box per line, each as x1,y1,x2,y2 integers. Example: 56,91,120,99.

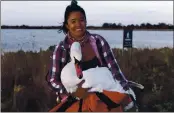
61,62,135,98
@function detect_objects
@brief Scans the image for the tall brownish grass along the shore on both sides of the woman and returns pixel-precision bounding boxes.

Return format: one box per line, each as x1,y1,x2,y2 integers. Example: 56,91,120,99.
1,48,174,112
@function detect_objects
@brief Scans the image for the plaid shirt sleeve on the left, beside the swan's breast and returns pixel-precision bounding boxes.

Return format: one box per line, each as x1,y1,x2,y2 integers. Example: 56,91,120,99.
46,43,65,93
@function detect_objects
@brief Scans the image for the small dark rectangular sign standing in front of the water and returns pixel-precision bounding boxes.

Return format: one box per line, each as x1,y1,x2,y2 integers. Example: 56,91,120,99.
123,29,133,48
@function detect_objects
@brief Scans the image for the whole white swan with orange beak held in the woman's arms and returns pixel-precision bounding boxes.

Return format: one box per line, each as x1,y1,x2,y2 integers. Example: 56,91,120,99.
61,42,141,99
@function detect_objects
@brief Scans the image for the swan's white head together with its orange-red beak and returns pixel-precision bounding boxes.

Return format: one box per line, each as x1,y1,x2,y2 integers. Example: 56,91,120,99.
70,42,83,79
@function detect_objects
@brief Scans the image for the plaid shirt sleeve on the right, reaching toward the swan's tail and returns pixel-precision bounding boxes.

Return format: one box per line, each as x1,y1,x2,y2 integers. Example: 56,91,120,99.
97,35,127,87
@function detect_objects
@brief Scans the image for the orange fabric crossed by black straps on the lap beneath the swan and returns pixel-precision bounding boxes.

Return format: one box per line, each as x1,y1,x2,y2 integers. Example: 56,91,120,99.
50,90,135,112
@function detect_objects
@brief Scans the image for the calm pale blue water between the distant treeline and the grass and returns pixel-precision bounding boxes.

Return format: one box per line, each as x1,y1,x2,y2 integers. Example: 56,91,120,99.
1,29,173,52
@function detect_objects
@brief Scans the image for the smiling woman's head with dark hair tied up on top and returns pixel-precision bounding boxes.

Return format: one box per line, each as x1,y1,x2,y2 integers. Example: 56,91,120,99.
60,2,86,40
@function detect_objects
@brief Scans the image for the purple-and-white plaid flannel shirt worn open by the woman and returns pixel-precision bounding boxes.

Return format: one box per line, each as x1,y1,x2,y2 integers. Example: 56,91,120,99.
46,32,127,93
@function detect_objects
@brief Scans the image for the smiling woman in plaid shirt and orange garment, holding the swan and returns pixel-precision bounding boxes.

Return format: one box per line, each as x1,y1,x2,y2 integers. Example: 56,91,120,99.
47,0,137,111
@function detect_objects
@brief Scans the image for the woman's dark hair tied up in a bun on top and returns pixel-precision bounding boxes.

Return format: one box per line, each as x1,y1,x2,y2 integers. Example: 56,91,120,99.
59,0,86,34
